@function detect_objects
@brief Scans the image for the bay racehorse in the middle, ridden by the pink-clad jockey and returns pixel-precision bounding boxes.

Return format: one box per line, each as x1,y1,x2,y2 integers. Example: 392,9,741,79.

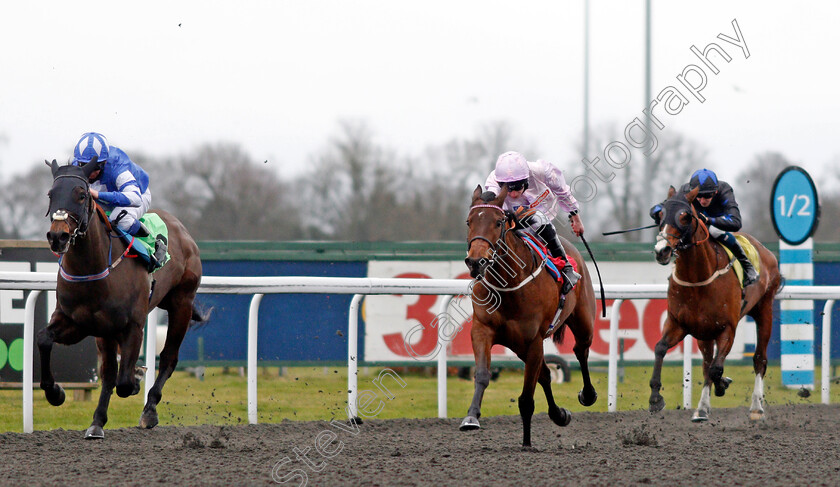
461,186,598,447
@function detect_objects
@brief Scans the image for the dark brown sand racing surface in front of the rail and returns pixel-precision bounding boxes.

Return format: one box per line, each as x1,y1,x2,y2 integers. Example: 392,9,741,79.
0,405,840,487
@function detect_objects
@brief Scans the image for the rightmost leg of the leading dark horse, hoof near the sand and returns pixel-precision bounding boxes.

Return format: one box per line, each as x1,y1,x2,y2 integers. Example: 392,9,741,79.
140,299,193,428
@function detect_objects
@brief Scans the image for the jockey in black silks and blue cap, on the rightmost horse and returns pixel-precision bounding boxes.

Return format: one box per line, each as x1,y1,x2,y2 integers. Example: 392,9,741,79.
650,169,758,287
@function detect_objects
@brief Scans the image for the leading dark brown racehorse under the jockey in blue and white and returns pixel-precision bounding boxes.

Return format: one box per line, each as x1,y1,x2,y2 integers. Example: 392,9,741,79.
42,160,205,438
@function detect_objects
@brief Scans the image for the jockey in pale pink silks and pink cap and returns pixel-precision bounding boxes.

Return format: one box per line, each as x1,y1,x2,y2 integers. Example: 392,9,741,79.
484,151,583,294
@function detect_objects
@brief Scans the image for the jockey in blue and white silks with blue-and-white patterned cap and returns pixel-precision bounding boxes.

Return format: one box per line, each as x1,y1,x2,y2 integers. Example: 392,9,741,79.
72,132,166,261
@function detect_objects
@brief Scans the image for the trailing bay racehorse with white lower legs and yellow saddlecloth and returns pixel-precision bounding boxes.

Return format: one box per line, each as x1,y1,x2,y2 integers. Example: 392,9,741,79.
650,186,782,421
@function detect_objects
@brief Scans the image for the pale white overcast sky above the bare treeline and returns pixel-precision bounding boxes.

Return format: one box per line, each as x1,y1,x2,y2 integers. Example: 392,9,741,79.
0,0,840,191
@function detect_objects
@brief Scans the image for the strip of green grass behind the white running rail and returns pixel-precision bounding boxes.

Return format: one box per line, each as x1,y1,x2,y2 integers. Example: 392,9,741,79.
0,365,840,432
